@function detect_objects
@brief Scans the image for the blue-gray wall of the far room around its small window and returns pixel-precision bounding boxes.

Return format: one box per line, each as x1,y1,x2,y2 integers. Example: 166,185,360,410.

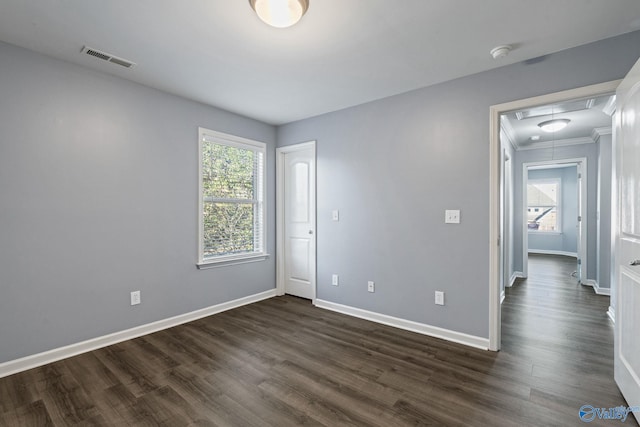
528,166,588,254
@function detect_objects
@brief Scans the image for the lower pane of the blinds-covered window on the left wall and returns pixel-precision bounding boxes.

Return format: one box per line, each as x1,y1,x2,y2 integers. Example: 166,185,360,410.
203,203,261,259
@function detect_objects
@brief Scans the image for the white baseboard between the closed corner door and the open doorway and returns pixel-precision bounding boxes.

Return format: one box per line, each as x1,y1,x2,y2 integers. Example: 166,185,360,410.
316,299,489,350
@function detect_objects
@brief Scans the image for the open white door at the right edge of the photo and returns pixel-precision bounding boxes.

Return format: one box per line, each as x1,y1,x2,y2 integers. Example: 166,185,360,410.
614,56,640,422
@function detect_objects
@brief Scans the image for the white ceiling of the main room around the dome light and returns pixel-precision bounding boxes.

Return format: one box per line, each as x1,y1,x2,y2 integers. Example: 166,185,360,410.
0,0,640,124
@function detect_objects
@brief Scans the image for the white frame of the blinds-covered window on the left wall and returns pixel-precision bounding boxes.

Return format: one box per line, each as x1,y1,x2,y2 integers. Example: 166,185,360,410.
196,127,269,269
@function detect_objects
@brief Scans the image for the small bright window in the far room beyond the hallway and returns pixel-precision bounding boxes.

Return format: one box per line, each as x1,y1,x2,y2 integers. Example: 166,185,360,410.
527,179,560,233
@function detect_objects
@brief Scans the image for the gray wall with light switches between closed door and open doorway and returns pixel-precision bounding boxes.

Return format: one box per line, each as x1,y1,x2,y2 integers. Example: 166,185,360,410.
278,32,640,338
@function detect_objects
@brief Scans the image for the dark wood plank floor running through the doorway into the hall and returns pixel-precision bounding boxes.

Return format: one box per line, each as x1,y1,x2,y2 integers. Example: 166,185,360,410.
0,257,636,427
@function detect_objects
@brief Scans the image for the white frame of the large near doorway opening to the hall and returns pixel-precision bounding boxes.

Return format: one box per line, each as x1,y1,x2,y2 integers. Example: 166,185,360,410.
489,80,621,351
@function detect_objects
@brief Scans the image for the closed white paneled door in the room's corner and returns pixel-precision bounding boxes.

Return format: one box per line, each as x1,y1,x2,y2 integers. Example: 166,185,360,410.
279,143,316,300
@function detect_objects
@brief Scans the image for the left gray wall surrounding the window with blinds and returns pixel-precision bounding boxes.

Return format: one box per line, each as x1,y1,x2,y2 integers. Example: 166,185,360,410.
0,44,276,362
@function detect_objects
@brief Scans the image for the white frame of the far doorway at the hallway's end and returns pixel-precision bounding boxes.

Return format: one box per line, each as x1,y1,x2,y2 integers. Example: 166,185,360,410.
521,157,588,284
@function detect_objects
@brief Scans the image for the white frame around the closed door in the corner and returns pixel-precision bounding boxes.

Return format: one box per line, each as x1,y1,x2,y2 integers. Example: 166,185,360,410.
276,141,318,305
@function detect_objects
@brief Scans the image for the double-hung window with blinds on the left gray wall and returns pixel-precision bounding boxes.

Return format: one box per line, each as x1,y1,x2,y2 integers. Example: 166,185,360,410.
198,128,266,266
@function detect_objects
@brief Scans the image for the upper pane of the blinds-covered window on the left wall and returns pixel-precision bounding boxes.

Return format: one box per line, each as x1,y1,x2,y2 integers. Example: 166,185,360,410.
202,142,258,199
